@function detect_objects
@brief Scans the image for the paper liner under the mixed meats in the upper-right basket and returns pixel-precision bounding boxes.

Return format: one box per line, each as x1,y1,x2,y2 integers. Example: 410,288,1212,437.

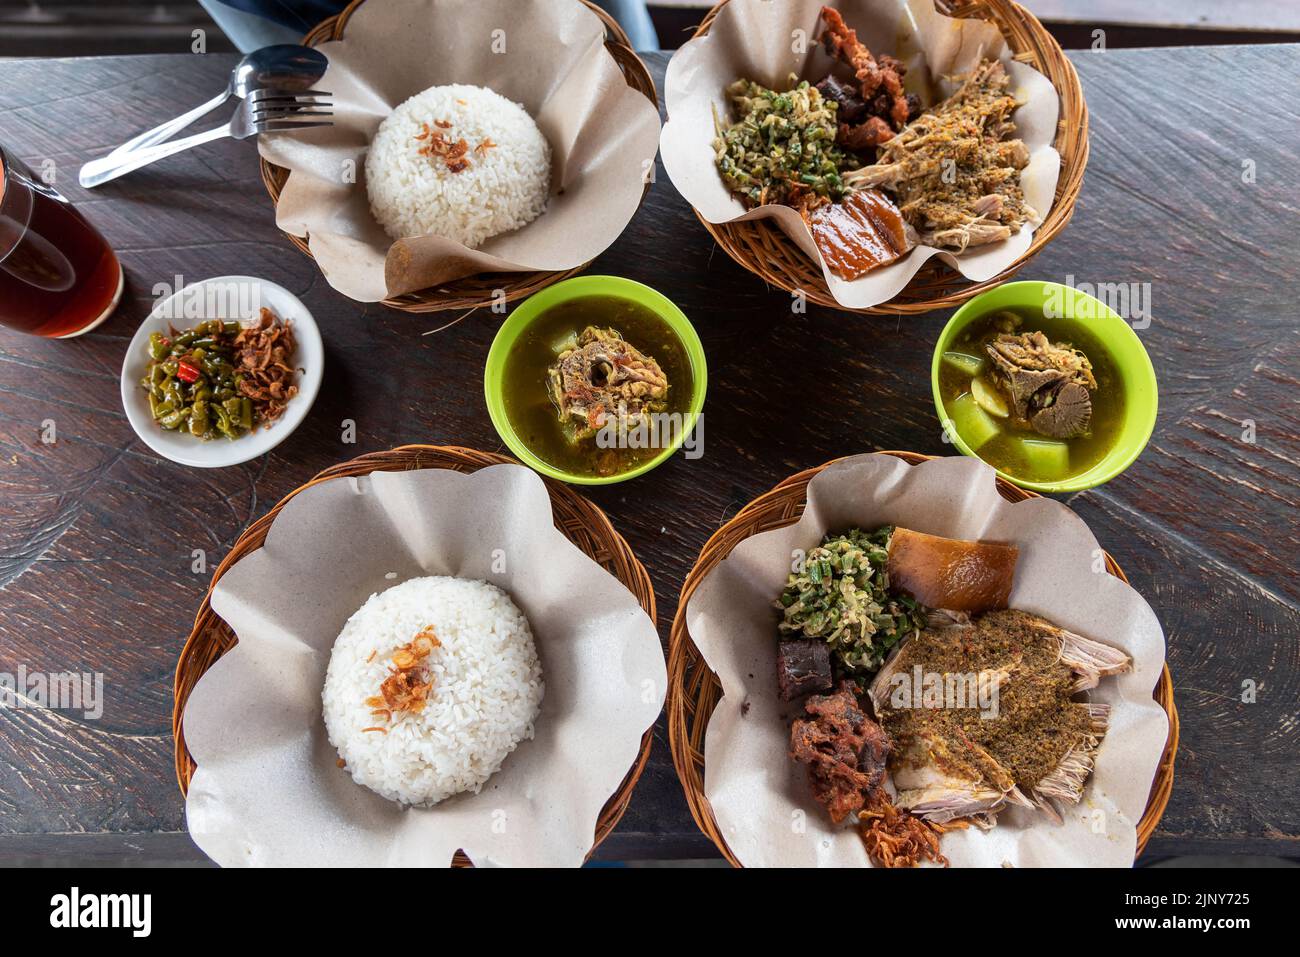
659,0,1061,309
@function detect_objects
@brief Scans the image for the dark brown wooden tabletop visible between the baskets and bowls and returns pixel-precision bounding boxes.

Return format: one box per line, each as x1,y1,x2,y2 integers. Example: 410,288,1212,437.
0,47,1300,862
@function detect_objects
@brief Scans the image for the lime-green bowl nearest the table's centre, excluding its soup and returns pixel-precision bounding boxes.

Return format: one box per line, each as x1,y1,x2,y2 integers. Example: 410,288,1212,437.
484,276,709,485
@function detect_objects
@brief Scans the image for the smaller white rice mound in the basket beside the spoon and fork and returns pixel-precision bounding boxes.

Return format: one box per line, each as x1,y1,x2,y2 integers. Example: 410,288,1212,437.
365,85,551,247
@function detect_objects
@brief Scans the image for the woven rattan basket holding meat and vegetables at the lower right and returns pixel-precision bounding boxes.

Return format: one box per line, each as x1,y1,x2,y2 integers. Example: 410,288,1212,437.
667,451,1178,867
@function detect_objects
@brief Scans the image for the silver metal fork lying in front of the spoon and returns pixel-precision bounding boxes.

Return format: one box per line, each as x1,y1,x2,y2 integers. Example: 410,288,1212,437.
78,90,334,189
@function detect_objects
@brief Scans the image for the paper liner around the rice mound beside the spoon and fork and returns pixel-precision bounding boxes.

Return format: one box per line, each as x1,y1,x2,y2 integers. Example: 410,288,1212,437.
257,0,659,302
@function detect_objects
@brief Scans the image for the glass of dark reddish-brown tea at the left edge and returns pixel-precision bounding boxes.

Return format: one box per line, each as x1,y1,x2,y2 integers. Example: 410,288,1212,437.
0,141,122,339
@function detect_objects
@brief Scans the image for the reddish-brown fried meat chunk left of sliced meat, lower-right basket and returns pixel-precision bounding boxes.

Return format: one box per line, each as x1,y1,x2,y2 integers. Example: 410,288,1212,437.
790,681,891,823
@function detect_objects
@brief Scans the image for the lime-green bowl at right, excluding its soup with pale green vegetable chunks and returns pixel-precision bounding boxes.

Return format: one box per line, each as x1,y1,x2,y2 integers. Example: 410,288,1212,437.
930,282,1158,492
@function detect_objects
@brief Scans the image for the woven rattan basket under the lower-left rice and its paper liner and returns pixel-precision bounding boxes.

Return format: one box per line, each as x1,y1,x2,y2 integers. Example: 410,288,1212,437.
172,445,655,867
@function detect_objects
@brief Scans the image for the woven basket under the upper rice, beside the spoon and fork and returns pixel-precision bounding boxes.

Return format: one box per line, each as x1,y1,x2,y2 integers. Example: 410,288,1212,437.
261,0,659,313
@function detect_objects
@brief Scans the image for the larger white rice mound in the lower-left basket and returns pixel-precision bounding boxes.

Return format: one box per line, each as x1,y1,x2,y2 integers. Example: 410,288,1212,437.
330,577,543,805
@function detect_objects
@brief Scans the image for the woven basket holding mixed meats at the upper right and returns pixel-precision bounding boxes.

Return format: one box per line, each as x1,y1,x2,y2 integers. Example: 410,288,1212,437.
694,0,1088,316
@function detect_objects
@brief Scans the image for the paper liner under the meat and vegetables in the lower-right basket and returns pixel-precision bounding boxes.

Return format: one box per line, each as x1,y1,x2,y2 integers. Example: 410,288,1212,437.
686,455,1169,867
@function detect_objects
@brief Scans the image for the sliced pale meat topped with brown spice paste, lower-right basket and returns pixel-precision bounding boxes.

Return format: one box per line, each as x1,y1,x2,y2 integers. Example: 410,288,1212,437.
868,610,1132,823
